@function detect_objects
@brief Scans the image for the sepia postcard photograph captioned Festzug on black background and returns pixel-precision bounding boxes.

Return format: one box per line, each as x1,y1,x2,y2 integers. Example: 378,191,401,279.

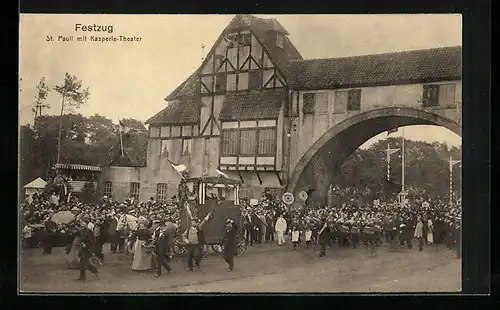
18,14,462,294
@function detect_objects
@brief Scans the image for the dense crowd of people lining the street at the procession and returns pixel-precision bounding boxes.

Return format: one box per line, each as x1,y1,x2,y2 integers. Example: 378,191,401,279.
21,188,461,279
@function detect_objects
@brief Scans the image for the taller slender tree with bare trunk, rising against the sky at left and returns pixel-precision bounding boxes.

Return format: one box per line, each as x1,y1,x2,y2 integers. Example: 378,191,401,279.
55,73,90,163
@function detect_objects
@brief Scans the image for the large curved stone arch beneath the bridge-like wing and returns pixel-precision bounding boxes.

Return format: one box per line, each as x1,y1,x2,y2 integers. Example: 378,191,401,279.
287,107,461,200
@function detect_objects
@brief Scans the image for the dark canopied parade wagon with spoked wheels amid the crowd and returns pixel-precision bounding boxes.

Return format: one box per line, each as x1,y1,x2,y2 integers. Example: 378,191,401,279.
173,176,246,256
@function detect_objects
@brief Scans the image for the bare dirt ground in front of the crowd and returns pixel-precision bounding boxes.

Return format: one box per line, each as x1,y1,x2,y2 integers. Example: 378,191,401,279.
20,240,461,293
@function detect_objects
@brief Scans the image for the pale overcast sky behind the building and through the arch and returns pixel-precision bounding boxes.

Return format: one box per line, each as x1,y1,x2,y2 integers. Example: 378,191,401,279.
19,14,462,145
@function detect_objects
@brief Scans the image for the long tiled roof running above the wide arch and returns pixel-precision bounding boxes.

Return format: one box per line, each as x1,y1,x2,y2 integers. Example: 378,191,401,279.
287,46,462,89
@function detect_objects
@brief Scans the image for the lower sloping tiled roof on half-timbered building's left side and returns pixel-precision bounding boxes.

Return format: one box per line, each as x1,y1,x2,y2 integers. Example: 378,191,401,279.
146,96,201,125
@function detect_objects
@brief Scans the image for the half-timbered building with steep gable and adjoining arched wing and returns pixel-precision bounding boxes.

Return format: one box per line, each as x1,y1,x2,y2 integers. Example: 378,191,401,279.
99,15,461,200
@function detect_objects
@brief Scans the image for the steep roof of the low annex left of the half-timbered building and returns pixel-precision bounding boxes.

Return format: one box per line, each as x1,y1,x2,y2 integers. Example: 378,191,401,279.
101,134,148,167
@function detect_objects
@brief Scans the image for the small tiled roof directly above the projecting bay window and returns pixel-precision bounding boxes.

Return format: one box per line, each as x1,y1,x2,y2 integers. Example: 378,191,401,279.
219,91,287,121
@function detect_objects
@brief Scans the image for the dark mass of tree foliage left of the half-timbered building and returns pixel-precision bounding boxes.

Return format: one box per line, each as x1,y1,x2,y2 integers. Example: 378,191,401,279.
20,114,147,185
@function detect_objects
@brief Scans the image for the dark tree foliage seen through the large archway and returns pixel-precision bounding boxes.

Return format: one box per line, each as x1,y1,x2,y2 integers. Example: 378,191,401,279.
333,138,461,196
